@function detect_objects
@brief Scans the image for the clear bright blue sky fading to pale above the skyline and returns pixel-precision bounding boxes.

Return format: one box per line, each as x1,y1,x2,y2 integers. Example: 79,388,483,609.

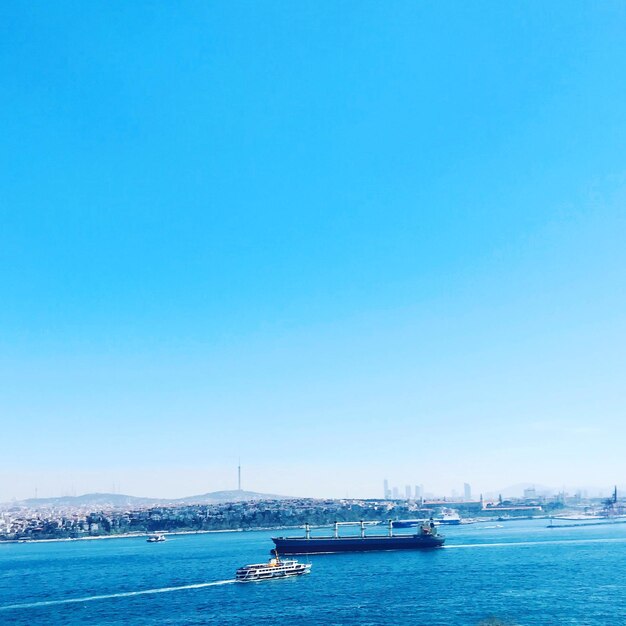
0,0,626,500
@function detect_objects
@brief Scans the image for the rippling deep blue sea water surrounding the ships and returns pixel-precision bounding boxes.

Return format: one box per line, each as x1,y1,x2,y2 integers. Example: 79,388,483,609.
0,520,626,626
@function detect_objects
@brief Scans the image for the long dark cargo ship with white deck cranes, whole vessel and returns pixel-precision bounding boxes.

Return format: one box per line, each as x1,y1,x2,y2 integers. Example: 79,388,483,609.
272,520,445,554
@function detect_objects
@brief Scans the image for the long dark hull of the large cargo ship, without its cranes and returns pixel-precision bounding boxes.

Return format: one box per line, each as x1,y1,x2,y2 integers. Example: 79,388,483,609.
272,535,445,554
